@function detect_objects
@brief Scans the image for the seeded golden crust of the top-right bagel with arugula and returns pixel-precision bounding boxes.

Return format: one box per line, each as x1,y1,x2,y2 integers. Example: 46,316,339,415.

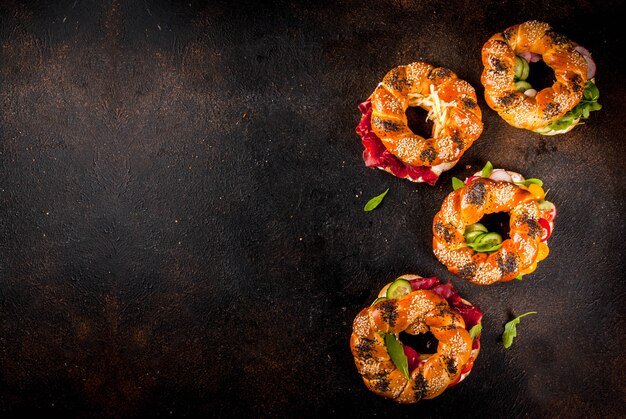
481,21,587,130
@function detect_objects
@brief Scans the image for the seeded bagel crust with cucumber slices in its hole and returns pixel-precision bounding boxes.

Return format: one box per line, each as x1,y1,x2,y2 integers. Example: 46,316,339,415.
433,178,542,285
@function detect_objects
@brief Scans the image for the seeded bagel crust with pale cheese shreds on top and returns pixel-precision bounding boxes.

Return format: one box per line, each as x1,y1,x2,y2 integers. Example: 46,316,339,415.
370,62,483,167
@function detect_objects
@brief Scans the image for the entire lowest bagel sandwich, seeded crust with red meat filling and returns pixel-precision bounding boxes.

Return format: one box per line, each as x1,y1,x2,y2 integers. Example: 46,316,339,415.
350,275,482,403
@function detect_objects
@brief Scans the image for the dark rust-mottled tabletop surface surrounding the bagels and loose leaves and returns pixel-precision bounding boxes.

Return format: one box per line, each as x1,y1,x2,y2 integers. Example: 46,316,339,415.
0,0,626,418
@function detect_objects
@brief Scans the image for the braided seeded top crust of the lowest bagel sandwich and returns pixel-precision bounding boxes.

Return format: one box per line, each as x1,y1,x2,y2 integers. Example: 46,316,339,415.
350,286,470,403
